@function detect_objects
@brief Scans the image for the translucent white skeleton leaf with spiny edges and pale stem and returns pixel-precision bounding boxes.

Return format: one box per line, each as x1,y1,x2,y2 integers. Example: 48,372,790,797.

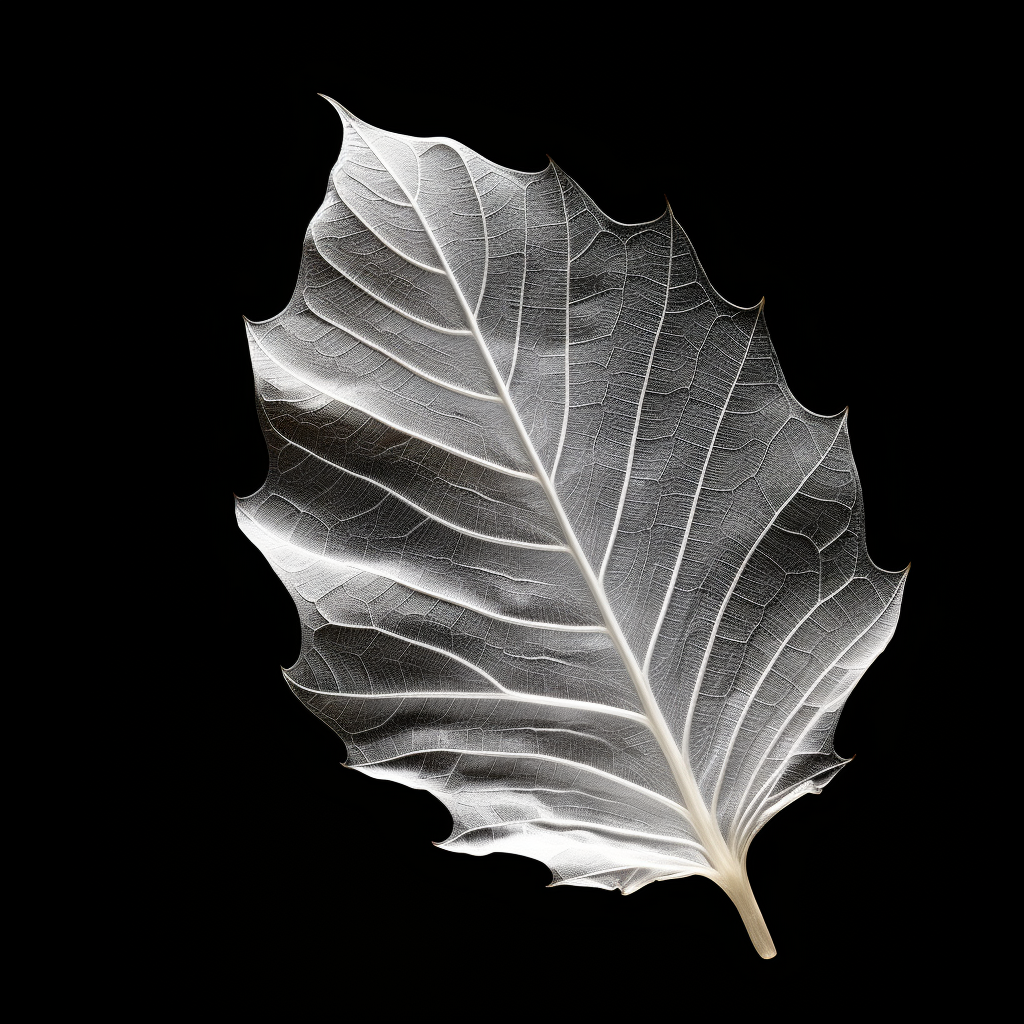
238,100,905,956
